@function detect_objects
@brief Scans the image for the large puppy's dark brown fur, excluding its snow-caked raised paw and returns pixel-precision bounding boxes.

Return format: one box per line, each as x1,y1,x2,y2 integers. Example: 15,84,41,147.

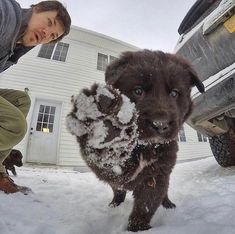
73,50,204,231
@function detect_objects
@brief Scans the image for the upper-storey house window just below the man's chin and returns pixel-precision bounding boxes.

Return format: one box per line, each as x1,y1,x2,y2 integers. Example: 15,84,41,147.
38,42,69,62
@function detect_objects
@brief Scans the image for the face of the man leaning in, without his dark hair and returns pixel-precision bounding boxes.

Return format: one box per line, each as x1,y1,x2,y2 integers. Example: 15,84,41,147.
20,9,64,46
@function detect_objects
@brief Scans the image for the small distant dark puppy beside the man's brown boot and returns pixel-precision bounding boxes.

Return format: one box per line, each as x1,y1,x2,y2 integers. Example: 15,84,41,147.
2,149,23,176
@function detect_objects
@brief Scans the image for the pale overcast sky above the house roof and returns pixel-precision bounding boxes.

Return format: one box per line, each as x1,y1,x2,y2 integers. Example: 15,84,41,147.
17,0,196,52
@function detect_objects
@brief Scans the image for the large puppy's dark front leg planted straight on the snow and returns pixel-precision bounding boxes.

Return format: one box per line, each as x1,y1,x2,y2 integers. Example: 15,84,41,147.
127,176,169,232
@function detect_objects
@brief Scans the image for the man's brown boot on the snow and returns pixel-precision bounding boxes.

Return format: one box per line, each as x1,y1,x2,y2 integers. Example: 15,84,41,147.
0,172,32,195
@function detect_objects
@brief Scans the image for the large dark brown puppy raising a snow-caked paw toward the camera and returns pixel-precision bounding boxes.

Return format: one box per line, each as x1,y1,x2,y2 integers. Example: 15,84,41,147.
67,50,204,231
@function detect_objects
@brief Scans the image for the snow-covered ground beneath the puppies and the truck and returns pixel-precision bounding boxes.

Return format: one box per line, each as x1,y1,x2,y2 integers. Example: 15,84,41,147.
0,158,235,234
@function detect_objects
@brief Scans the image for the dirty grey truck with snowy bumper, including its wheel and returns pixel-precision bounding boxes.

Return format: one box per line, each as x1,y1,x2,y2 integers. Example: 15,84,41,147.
175,0,235,167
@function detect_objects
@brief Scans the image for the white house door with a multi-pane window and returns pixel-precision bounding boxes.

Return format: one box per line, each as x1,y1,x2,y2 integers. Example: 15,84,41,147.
27,100,61,164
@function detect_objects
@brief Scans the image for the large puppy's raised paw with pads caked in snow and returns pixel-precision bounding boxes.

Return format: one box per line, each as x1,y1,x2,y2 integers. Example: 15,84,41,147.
66,84,138,141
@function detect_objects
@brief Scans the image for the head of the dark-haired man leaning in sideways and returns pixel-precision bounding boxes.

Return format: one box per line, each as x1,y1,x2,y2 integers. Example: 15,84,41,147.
20,0,71,46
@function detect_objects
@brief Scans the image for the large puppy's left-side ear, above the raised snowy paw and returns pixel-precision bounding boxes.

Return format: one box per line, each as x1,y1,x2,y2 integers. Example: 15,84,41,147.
105,51,133,85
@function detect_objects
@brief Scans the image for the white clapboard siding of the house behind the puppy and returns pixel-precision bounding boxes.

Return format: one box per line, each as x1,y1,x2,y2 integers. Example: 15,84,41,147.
0,26,213,166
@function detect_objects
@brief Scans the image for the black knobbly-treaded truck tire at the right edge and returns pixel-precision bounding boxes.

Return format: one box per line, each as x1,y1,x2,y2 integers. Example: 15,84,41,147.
209,133,235,167
